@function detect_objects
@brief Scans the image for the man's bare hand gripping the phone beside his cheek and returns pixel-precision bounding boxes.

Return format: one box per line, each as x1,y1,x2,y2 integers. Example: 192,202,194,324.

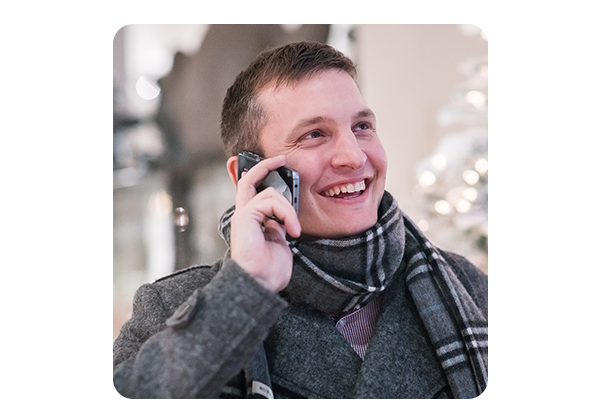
231,156,300,292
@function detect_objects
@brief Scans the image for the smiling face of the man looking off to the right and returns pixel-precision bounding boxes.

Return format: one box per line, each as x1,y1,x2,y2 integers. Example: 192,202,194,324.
258,69,387,238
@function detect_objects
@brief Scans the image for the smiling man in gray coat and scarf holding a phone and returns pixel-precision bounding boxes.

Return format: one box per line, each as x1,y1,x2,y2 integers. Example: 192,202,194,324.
113,42,488,398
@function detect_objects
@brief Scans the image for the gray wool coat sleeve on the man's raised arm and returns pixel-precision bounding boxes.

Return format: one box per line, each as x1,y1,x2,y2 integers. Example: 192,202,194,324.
113,260,287,398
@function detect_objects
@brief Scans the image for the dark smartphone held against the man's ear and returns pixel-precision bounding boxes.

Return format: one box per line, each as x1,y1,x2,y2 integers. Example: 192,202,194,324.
238,151,300,215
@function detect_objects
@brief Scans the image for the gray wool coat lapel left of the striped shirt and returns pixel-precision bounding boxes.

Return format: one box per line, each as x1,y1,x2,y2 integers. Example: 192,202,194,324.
265,305,362,399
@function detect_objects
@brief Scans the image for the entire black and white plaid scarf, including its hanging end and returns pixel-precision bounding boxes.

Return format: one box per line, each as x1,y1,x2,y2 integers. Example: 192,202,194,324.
219,191,488,399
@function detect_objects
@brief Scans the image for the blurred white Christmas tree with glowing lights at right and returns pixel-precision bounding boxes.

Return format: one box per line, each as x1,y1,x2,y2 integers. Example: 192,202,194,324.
415,24,488,273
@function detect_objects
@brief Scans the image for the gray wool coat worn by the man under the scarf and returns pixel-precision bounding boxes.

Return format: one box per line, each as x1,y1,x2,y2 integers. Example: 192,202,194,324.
113,251,488,399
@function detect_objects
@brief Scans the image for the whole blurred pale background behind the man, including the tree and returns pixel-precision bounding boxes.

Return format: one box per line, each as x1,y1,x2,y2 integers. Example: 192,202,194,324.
113,24,488,340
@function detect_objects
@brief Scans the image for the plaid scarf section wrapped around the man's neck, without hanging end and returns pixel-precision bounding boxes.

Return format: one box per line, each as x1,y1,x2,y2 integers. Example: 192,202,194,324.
282,194,404,314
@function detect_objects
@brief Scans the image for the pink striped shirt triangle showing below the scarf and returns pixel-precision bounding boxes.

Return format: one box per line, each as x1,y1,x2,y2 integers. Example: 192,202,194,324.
331,295,381,360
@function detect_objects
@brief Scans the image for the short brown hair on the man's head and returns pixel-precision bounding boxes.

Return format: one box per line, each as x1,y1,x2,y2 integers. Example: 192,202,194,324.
221,41,356,157
